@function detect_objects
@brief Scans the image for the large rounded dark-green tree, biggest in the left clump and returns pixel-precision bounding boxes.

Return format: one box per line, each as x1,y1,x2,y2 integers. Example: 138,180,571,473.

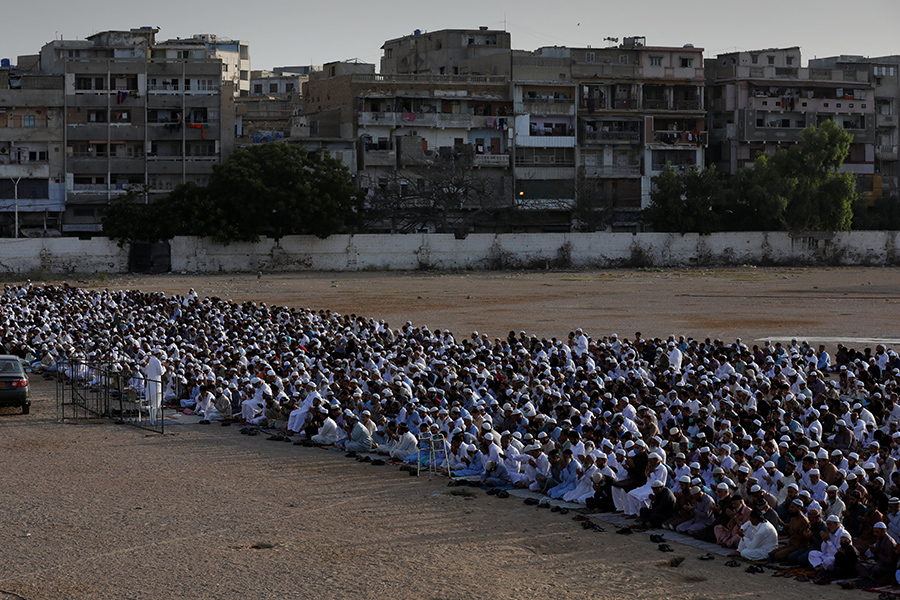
208,144,362,243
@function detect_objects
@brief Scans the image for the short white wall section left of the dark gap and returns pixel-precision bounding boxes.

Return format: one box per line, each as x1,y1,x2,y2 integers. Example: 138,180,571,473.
0,238,128,276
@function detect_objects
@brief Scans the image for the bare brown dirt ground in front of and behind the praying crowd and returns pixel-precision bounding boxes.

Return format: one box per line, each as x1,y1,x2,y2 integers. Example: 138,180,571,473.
0,268,900,600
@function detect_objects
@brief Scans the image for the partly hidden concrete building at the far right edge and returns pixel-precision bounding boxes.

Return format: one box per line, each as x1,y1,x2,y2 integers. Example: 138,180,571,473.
809,55,900,198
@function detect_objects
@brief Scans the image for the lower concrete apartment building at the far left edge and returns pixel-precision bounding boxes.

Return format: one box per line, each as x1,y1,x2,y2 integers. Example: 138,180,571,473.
0,66,65,237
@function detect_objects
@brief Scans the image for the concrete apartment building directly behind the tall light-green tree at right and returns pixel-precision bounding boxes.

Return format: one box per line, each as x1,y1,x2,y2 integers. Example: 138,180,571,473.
705,47,876,190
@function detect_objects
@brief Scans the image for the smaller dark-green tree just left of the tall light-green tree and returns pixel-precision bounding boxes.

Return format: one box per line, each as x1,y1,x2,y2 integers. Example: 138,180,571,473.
644,165,722,233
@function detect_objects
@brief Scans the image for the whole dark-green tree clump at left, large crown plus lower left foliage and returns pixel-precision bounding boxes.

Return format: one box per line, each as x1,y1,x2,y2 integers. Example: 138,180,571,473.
103,144,362,243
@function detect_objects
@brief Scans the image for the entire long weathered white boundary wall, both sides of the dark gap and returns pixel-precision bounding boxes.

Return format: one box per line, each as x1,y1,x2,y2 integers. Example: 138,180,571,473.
0,231,900,275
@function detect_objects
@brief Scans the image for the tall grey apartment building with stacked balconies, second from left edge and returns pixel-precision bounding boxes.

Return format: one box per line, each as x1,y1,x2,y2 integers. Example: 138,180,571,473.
20,28,234,233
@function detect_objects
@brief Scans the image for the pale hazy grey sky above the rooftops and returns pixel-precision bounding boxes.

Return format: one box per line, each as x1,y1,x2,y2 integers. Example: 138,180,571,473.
0,0,900,69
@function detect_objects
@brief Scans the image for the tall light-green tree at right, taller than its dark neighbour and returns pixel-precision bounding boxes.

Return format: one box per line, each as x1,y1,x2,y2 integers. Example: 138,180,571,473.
734,121,857,231
